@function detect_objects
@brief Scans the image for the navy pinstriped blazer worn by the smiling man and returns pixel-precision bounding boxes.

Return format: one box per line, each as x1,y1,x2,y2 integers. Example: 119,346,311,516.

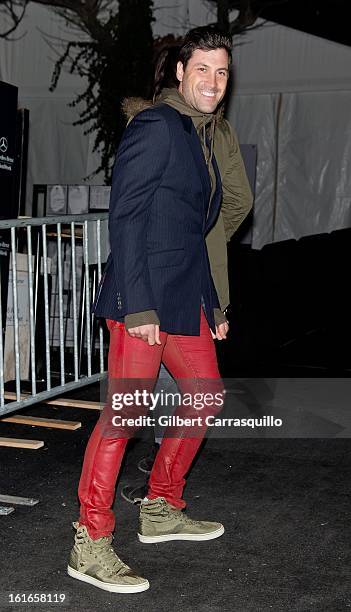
93,103,222,335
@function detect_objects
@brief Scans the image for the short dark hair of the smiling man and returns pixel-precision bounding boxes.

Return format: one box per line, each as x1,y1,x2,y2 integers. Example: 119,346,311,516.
178,26,232,69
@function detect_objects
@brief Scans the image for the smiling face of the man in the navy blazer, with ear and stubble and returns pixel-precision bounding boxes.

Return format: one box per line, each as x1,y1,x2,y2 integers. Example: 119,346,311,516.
177,49,229,113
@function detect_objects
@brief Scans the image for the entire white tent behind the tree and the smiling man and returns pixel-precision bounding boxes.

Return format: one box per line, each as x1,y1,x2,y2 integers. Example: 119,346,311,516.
0,0,351,248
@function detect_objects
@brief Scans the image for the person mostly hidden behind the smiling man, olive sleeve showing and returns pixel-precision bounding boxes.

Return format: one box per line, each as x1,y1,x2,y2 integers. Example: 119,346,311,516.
121,44,252,503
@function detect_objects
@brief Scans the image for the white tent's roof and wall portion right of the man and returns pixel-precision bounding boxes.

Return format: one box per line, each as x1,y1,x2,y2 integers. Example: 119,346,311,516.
229,23,351,248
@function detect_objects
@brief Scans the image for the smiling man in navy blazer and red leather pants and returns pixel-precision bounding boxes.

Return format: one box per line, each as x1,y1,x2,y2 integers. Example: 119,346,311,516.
68,28,231,593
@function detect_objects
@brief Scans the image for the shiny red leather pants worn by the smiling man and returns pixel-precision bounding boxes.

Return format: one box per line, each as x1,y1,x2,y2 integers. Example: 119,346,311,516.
78,310,223,539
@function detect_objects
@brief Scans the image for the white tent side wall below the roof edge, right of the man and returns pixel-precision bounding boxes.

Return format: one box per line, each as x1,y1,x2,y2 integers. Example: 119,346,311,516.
229,91,351,248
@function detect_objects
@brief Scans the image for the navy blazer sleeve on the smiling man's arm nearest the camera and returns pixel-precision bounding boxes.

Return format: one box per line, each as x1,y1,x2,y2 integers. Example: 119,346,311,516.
109,109,170,314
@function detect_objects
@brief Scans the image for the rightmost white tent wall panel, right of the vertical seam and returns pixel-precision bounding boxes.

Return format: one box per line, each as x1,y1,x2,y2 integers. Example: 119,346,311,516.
274,91,351,240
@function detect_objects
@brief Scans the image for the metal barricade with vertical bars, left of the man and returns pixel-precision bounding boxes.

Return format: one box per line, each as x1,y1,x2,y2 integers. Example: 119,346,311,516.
0,213,108,418
